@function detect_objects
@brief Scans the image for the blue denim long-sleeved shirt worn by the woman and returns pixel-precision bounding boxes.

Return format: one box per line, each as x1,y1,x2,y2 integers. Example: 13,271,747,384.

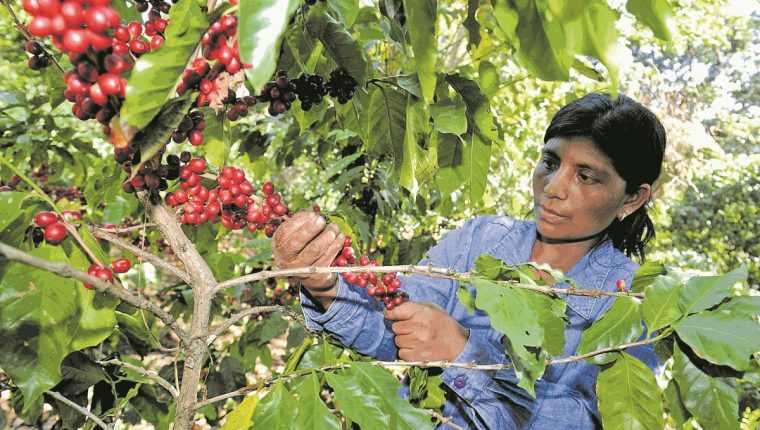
301,216,658,430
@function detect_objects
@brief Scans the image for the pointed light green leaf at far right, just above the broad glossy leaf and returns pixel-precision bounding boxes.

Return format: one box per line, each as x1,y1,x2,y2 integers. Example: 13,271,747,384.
678,267,747,315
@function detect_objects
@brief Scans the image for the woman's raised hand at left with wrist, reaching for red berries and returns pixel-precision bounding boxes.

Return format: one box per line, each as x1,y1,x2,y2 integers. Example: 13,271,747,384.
272,212,345,309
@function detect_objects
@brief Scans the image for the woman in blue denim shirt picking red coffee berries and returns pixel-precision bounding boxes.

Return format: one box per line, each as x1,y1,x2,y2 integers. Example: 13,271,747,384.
274,94,665,429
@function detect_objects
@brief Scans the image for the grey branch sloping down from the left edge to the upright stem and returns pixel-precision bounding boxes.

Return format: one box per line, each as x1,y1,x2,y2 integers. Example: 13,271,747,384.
0,242,190,344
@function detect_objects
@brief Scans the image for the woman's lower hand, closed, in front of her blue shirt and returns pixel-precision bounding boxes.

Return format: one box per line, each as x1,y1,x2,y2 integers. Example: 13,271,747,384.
385,302,469,361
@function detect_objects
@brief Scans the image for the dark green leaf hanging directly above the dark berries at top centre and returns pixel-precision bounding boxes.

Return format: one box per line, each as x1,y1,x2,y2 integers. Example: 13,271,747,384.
319,15,367,85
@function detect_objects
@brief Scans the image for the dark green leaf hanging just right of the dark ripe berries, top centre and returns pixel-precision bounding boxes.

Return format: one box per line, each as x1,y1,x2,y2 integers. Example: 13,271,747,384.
364,87,407,168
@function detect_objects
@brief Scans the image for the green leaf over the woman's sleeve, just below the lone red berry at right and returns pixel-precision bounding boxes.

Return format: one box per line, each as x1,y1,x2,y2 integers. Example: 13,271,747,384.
578,297,644,364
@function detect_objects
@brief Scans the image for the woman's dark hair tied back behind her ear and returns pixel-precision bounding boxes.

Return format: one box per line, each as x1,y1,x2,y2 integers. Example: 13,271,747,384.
544,93,665,260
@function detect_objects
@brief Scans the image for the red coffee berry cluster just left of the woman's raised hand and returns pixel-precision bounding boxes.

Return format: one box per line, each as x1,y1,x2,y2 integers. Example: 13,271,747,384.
166,158,288,237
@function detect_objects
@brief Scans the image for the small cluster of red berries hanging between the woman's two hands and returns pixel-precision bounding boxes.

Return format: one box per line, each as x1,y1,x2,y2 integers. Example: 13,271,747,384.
331,236,409,310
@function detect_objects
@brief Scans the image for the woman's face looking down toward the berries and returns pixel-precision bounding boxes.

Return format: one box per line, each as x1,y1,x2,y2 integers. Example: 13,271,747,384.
533,137,635,239
